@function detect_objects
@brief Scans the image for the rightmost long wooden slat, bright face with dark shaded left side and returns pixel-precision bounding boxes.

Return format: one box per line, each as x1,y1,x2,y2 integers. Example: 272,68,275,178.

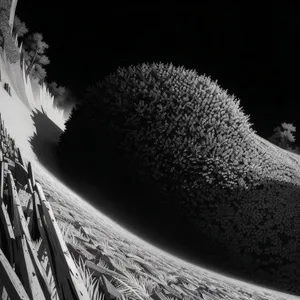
35,182,89,300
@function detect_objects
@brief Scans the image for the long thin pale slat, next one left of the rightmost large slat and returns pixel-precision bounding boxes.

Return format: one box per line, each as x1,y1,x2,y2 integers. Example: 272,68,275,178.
8,171,51,300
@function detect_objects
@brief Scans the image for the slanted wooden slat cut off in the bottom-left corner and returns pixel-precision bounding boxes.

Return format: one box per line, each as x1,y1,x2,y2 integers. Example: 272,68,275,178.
0,249,30,300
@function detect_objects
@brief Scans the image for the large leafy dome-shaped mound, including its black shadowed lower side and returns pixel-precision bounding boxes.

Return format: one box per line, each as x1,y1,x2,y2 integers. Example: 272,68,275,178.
58,63,300,292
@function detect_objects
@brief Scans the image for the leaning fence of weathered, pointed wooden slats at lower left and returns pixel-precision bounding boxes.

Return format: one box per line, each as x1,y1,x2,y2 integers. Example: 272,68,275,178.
0,115,96,300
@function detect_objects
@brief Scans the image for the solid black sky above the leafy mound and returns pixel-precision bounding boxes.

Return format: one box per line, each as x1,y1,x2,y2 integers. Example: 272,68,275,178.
16,0,300,141
